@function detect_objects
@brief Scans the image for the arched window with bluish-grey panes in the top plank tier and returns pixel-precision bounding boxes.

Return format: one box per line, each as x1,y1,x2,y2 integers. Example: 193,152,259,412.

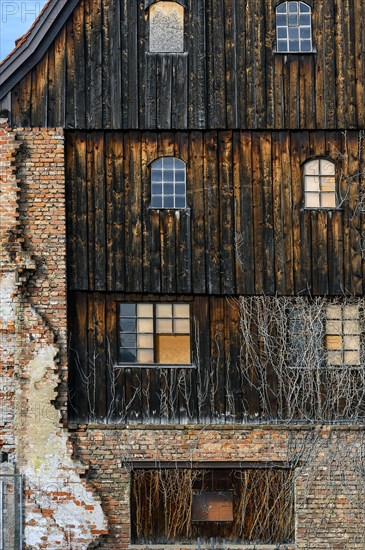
276,2,313,53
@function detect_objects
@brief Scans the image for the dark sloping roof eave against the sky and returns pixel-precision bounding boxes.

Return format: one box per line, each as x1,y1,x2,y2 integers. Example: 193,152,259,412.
0,0,79,101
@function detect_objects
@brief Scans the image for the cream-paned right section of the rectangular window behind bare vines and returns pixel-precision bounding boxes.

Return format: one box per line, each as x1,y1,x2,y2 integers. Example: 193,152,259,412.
325,304,361,365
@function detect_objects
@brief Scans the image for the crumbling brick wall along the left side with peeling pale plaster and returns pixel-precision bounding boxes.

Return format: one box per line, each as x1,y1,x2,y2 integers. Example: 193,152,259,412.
0,121,106,550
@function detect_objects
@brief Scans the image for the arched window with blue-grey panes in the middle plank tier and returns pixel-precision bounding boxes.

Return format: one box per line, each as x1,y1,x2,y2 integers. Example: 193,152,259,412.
151,157,186,209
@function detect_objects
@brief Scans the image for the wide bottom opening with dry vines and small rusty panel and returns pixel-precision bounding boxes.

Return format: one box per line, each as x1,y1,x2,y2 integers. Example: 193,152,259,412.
131,467,294,545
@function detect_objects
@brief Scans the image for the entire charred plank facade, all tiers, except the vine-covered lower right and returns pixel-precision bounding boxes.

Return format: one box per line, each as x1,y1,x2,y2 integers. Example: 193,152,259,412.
0,0,365,423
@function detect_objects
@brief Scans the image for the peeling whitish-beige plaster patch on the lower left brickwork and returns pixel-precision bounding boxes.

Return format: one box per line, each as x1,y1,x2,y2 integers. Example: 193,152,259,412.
16,345,106,550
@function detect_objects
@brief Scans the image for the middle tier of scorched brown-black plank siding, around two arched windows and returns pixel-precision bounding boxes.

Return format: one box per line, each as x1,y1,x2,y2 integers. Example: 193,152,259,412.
66,131,365,296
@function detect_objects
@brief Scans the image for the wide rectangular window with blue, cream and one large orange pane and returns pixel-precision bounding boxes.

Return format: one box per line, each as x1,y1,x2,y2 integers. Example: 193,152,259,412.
119,303,191,365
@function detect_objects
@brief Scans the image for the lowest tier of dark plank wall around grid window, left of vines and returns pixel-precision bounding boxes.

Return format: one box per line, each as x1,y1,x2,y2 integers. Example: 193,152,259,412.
69,292,260,423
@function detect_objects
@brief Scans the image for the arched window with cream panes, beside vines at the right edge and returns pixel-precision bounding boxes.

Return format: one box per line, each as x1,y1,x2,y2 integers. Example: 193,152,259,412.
304,159,336,208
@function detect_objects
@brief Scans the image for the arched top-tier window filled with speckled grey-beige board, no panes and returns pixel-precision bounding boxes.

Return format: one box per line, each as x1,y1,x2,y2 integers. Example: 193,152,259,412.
149,2,184,53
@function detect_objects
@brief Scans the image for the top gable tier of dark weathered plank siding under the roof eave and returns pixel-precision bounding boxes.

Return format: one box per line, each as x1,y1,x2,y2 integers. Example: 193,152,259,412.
7,0,365,130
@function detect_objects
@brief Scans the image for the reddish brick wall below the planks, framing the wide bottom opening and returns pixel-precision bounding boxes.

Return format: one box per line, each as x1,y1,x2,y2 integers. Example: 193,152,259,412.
72,426,365,550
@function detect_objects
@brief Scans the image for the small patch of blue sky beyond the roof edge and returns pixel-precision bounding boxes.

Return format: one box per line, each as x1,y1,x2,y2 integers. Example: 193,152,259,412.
0,0,47,60
